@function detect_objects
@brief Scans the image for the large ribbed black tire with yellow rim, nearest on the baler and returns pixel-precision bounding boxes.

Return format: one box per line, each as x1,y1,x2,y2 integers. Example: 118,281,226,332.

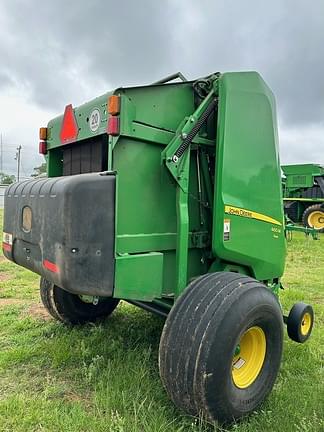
159,272,283,423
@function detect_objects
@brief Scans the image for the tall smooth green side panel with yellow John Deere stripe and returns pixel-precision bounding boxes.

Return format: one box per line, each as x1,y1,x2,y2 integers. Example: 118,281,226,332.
213,72,286,280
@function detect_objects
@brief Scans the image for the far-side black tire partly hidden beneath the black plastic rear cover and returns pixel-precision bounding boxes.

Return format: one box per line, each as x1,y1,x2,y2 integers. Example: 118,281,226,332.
40,278,119,324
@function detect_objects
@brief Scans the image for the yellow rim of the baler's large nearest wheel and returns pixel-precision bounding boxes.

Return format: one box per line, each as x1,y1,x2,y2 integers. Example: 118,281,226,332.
232,326,267,388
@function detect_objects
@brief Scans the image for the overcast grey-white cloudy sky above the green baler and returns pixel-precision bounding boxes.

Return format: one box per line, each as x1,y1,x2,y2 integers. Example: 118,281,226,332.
0,0,324,175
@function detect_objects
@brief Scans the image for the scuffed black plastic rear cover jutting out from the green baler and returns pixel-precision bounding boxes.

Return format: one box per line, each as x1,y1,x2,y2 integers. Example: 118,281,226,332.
4,173,115,296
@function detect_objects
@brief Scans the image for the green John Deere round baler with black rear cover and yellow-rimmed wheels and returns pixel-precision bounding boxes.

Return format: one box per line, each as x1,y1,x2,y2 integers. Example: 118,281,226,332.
3,72,313,421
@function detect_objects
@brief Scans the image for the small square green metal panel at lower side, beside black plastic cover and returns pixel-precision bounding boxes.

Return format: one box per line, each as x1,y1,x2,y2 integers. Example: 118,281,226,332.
114,252,163,301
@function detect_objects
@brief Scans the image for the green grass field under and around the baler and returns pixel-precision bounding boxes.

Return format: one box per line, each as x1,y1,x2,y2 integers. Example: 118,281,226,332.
0,208,324,432
